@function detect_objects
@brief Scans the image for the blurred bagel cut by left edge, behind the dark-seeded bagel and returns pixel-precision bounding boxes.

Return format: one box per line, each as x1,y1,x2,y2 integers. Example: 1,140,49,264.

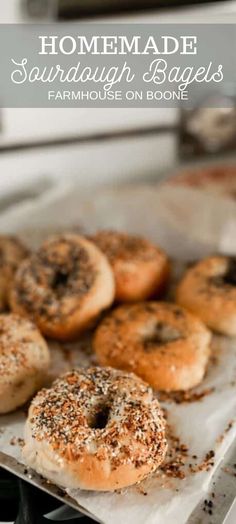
0,235,29,311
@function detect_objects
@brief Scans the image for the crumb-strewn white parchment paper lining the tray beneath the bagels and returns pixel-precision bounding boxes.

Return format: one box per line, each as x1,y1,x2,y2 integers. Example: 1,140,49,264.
0,181,236,524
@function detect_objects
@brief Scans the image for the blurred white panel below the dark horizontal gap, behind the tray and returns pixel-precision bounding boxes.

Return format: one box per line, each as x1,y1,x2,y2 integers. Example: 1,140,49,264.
0,132,176,196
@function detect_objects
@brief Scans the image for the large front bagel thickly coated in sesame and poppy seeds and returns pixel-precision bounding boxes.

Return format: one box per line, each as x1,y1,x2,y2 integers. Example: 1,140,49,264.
23,367,167,491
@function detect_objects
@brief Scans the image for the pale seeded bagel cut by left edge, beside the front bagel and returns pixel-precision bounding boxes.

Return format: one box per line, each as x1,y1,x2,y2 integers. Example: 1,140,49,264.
0,314,50,414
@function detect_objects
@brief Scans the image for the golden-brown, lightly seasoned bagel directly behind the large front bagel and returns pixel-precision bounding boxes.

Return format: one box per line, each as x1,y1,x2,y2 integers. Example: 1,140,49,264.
93,302,210,391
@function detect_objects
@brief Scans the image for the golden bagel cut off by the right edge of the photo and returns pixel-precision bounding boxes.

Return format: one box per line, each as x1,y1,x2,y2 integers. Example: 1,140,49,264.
176,256,236,336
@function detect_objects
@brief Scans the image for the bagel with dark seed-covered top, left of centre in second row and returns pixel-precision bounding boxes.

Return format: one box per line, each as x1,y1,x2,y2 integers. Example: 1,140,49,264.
11,234,114,340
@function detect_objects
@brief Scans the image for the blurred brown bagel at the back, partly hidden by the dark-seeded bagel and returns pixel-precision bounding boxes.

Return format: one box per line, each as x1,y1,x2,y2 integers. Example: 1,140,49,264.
89,231,169,302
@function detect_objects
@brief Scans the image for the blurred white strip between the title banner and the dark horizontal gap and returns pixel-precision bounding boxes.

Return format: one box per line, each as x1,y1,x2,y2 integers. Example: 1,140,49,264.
0,108,177,146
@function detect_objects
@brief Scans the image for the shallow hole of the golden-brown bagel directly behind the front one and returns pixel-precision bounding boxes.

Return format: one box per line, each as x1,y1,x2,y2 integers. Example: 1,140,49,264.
144,322,183,351
